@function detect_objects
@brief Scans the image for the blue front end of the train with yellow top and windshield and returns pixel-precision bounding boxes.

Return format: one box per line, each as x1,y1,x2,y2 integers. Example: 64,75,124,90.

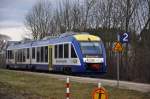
75,34,107,73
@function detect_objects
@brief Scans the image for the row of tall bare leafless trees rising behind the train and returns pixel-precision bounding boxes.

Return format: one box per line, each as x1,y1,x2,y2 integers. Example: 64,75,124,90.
25,0,150,40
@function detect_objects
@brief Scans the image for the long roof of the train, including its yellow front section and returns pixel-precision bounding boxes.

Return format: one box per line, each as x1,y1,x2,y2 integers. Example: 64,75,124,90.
7,32,101,50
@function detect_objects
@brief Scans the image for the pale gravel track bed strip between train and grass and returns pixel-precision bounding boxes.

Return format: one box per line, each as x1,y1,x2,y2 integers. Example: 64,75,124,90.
9,70,150,92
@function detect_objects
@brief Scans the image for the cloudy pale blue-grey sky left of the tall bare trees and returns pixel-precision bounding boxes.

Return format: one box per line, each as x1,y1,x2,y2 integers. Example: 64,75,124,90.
0,0,59,40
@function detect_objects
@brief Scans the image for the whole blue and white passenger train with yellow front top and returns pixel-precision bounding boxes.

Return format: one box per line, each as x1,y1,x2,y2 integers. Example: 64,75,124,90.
6,33,107,73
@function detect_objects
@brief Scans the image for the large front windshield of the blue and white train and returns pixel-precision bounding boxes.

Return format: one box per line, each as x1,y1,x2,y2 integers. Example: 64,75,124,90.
80,42,102,57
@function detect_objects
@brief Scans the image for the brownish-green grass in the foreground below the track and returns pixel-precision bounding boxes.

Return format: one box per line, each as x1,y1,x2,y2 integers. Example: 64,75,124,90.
0,69,150,99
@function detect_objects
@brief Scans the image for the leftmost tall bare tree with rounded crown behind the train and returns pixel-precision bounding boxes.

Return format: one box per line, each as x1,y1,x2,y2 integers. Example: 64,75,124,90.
25,1,52,39
